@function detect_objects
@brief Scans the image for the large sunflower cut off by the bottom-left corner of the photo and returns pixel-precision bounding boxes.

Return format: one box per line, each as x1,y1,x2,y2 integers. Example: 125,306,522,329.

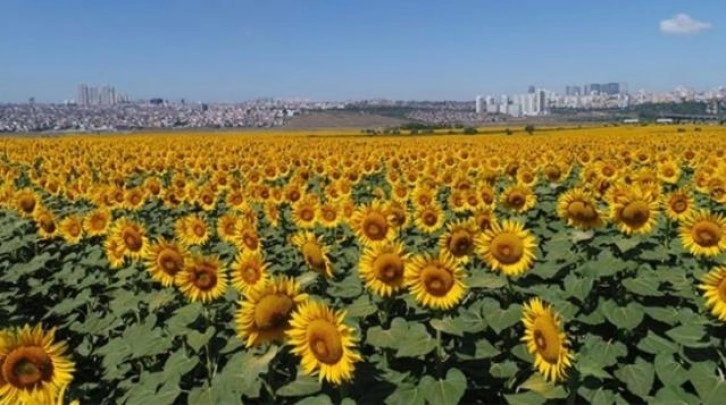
0,325,75,405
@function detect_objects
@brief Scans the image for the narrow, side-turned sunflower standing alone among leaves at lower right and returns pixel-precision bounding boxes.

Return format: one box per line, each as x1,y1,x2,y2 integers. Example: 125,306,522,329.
522,298,573,382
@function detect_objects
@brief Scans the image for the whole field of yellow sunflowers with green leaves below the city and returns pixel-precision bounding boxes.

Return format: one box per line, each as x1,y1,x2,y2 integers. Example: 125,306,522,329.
0,126,726,405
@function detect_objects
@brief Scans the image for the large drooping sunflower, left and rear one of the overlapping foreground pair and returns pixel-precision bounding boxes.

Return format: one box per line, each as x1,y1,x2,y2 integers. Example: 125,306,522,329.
235,277,308,347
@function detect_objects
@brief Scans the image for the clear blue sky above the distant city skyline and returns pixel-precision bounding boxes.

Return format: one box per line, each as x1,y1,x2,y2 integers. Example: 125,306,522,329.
0,0,726,102
